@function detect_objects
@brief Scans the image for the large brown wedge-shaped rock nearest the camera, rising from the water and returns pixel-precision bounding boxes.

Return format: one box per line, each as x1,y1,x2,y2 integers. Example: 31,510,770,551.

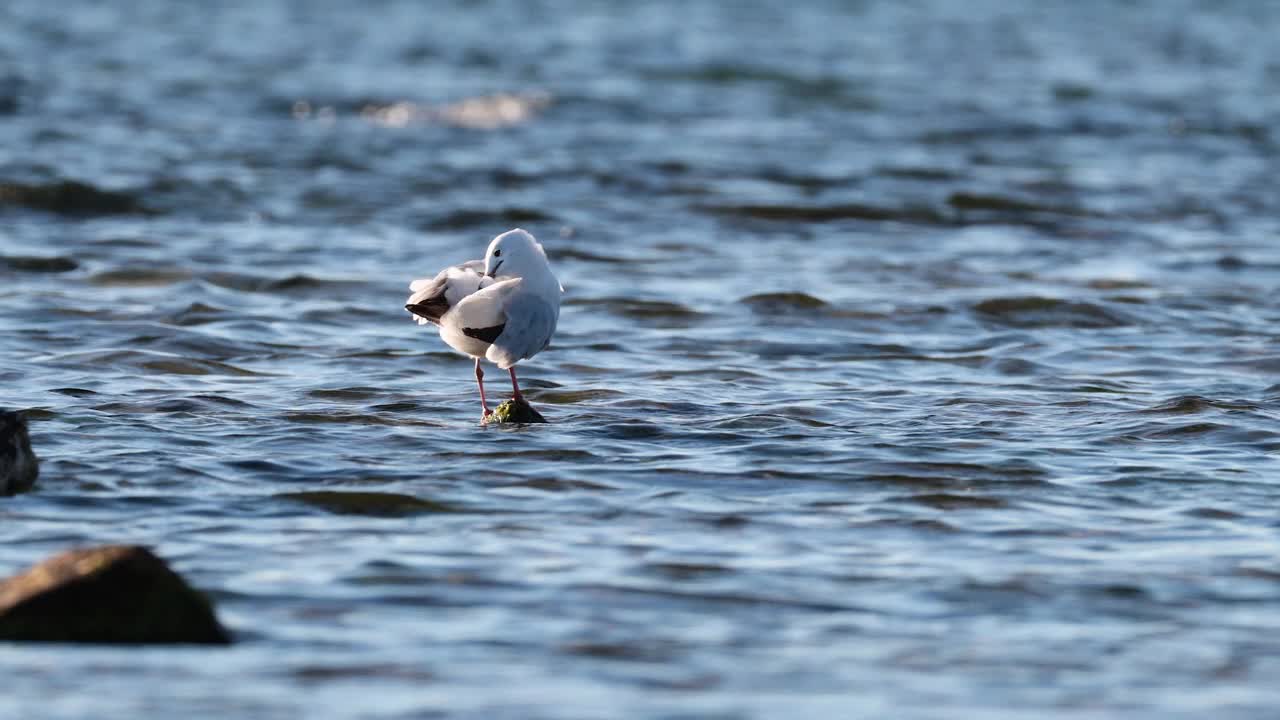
0,544,230,644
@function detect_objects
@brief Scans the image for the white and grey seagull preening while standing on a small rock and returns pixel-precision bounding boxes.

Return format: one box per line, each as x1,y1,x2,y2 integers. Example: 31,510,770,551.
404,228,564,419
